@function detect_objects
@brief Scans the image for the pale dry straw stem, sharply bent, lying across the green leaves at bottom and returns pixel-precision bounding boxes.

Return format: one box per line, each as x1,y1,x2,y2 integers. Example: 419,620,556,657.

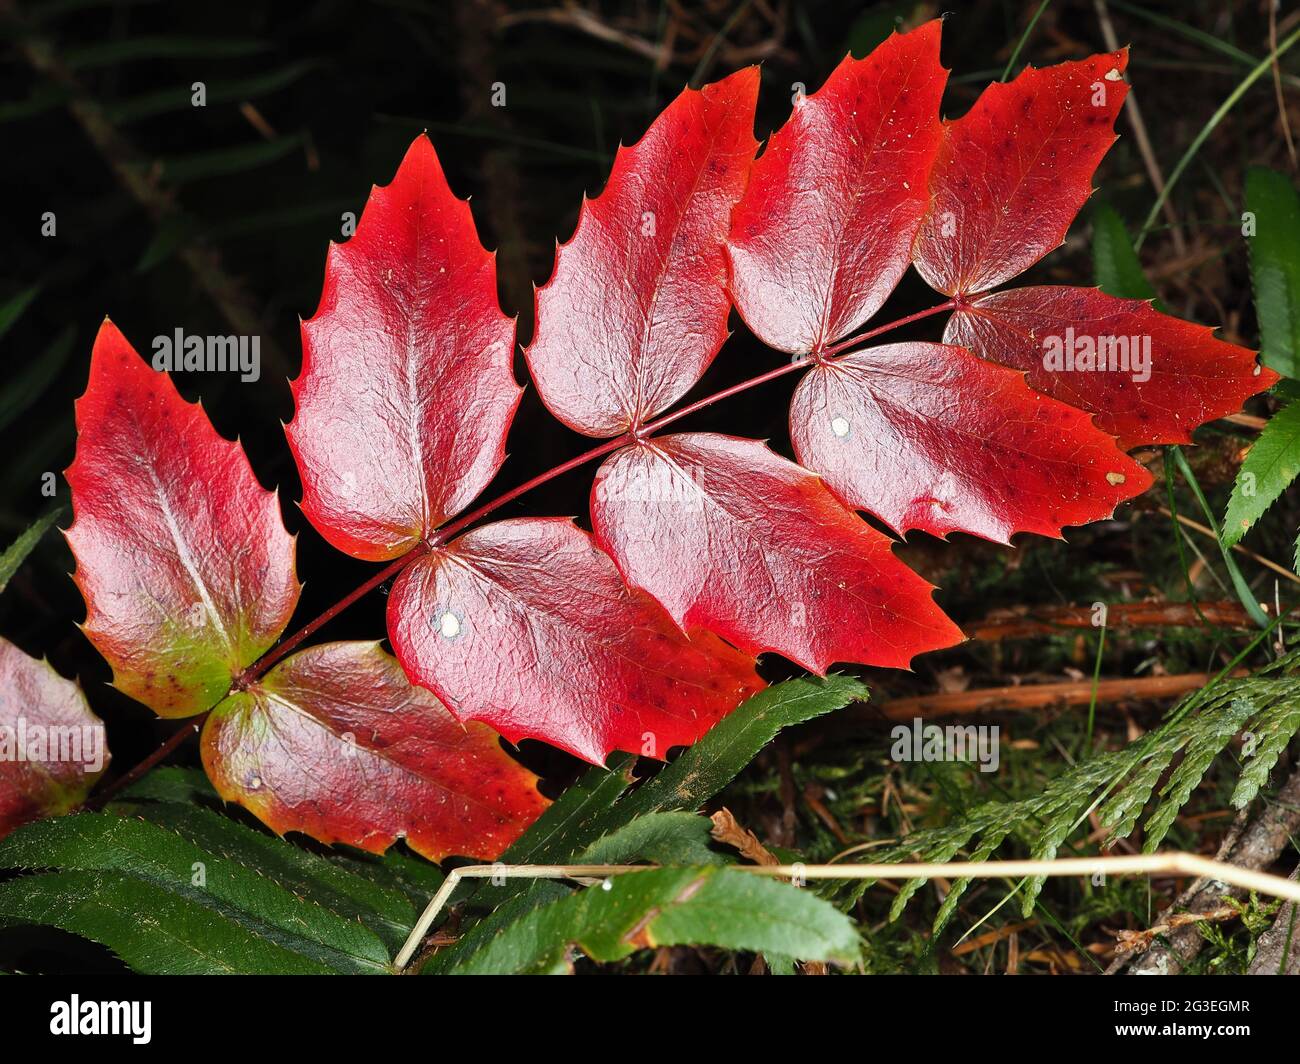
393,852,1300,972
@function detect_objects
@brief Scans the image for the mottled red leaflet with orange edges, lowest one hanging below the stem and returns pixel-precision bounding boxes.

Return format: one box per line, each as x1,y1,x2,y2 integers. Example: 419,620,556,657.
202,643,546,861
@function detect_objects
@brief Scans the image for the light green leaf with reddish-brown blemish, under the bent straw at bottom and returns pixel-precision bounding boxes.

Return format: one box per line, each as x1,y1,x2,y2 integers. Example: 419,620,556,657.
451,868,861,974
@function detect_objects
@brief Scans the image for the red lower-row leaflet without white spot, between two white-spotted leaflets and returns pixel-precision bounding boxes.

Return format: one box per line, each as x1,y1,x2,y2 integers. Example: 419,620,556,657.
592,433,962,672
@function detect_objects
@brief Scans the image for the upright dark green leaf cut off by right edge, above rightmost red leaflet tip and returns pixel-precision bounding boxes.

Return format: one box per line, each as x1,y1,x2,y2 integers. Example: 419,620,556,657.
1245,166,1300,377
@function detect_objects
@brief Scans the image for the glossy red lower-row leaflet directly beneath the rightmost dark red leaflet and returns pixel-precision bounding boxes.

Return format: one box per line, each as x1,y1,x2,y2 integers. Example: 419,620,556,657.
790,343,1151,542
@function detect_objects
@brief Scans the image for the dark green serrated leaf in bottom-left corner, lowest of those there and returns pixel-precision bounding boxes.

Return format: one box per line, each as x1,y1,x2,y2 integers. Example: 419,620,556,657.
0,871,332,976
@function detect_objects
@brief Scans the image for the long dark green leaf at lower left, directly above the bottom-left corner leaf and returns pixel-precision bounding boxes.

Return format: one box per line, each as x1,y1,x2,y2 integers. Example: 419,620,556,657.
0,813,389,973
